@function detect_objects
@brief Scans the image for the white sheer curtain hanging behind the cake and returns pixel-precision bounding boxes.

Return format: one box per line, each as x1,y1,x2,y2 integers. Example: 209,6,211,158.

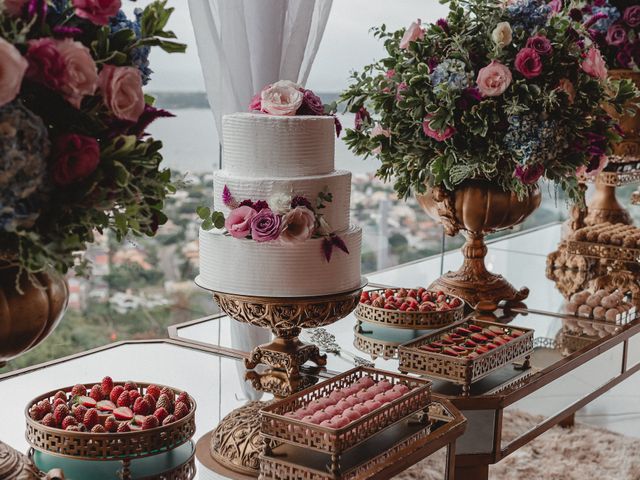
189,0,333,399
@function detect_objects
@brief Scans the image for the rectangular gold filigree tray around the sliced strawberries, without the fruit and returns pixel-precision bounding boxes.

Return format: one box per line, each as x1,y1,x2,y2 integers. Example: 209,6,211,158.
398,320,533,394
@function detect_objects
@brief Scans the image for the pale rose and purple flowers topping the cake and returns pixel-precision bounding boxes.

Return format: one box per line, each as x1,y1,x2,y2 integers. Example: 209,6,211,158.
249,80,342,137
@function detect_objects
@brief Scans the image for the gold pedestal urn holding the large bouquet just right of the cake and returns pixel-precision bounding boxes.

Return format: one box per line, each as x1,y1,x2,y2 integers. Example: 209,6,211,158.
416,180,542,306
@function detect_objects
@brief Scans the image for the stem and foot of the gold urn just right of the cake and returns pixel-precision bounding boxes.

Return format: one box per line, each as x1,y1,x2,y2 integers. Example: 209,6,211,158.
429,233,529,307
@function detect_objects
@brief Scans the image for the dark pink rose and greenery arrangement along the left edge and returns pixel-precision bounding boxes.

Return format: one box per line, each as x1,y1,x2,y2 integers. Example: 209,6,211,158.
0,0,185,282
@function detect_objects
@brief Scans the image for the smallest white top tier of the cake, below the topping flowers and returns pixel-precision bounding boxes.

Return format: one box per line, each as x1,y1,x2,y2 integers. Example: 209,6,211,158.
222,113,335,177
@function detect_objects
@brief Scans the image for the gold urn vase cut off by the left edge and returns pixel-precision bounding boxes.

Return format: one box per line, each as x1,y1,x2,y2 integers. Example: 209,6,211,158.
0,263,69,366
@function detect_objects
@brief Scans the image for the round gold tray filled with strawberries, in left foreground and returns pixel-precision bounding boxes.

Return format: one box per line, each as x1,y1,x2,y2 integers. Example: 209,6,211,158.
25,377,196,478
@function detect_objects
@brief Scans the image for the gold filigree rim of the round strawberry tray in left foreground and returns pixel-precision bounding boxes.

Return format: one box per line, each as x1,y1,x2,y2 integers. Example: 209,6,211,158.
24,382,196,464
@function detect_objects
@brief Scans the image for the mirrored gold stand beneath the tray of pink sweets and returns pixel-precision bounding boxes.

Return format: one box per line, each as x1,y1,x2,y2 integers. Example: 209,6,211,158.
260,396,466,480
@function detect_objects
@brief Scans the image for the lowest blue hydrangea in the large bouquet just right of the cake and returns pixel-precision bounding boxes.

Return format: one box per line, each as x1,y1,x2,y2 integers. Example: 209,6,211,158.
503,114,569,165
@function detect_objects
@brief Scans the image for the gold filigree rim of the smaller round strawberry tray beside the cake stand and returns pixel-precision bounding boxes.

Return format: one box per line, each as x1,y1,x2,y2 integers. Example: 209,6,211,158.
355,288,465,330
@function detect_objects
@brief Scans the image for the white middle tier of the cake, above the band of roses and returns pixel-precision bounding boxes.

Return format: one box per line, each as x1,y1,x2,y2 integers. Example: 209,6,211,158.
213,170,351,231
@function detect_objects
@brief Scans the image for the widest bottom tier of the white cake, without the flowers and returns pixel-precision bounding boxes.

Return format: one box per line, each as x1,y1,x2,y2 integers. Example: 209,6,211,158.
196,226,362,297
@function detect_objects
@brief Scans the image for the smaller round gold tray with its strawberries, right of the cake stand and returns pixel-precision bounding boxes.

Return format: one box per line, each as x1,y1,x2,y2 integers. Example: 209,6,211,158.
355,287,465,330
